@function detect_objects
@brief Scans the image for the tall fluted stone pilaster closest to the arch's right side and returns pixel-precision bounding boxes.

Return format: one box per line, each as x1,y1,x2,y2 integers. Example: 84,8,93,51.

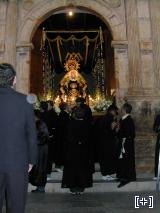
125,0,142,93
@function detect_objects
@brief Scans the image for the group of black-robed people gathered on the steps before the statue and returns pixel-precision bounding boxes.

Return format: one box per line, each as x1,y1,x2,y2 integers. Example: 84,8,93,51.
29,98,136,194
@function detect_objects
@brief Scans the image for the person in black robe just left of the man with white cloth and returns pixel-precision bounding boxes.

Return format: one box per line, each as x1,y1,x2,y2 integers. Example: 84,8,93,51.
98,106,118,181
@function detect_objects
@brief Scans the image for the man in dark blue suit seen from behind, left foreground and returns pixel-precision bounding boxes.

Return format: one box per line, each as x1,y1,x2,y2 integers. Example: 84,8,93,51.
0,64,37,213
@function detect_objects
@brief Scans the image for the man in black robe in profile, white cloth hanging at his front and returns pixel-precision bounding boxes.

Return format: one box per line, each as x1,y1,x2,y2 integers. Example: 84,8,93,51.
117,103,136,188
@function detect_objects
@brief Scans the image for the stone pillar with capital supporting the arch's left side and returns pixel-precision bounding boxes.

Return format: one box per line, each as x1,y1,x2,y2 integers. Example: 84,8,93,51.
16,43,33,94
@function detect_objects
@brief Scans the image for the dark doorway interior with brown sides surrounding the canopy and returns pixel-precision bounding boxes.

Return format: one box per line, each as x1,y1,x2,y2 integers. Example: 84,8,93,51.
30,12,116,96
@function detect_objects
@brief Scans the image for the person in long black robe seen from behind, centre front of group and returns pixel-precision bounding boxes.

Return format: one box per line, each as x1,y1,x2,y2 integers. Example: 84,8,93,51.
62,108,93,194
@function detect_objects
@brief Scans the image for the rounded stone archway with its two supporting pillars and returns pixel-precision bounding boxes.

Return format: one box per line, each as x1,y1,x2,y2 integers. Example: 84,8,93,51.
16,0,128,100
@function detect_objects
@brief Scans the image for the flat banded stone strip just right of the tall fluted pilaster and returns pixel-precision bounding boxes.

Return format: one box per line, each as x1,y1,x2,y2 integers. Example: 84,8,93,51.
137,0,154,93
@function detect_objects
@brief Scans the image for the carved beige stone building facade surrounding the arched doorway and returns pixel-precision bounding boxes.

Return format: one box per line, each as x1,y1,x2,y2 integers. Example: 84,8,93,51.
0,0,160,172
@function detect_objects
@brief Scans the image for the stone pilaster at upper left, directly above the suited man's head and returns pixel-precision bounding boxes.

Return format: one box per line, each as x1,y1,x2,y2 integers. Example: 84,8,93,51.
4,0,17,66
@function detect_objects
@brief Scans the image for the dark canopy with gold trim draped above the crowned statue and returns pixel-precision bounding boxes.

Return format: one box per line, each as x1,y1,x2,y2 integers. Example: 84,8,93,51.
42,28,103,73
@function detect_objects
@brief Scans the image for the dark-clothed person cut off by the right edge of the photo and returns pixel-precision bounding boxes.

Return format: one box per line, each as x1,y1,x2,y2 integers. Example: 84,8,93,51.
153,114,160,180
